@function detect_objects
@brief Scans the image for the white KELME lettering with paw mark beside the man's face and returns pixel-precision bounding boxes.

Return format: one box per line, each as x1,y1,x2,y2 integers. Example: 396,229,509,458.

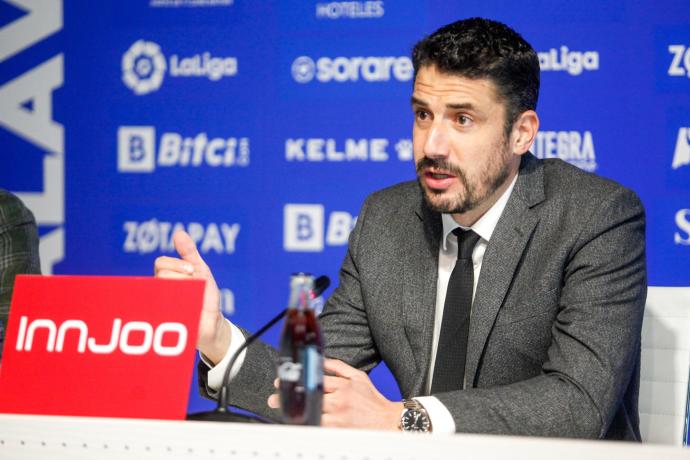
285,137,413,163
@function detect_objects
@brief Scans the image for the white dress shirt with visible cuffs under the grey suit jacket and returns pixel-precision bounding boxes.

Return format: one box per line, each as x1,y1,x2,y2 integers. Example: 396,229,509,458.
201,176,517,433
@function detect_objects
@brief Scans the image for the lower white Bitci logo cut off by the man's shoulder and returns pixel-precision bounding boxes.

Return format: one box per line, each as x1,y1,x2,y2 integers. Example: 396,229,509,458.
283,203,357,252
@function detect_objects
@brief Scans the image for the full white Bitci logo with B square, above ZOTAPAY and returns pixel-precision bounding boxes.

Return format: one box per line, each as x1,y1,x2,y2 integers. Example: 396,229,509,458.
117,126,250,173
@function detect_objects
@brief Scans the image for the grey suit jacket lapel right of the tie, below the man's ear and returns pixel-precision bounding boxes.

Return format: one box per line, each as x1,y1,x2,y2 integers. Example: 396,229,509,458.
465,153,544,387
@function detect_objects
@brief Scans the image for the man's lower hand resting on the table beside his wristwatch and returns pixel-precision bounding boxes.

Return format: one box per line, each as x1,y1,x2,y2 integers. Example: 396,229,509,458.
268,359,403,430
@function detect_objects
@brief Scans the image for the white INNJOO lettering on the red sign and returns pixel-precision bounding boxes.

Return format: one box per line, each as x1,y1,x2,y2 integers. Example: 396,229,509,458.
16,316,187,356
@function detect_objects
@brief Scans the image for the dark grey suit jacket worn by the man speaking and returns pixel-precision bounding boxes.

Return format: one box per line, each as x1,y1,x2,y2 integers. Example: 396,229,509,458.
202,154,646,440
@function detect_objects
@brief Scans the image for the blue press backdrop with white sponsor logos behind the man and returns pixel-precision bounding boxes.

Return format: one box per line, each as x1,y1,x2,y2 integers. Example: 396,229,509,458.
0,0,690,442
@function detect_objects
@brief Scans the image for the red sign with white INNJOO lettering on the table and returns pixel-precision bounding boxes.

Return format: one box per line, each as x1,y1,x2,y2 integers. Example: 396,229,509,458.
0,276,204,420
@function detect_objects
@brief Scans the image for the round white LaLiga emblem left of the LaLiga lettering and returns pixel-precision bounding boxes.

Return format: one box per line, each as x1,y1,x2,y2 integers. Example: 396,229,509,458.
122,40,167,95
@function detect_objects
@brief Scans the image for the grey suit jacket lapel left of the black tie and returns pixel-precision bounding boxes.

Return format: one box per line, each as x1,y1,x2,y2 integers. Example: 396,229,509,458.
400,191,443,395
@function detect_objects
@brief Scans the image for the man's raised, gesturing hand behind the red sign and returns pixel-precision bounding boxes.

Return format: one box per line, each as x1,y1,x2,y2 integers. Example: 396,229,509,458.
154,231,231,364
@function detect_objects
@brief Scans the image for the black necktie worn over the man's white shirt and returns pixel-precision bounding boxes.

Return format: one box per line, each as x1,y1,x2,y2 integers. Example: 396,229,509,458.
431,228,479,394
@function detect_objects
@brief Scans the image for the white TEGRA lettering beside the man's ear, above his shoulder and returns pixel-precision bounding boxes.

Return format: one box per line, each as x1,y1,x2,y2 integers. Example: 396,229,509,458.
533,131,597,172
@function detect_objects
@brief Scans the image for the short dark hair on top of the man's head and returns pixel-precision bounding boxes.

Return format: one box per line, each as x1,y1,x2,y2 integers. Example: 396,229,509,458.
412,18,539,136
